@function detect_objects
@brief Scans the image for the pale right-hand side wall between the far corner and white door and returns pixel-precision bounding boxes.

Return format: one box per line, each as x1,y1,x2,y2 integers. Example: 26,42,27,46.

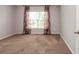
61,5,76,53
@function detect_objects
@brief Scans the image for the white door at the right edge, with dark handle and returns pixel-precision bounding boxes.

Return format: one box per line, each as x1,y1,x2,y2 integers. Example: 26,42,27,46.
75,5,79,54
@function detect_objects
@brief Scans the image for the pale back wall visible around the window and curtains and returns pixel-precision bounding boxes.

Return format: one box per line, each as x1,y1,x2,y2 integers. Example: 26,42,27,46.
17,6,60,34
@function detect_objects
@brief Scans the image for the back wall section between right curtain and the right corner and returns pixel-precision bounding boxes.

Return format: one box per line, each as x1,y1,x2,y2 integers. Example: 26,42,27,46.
50,6,61,34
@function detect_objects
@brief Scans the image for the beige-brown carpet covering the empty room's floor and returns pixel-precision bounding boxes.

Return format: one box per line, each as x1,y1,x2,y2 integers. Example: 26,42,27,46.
0,35,71,54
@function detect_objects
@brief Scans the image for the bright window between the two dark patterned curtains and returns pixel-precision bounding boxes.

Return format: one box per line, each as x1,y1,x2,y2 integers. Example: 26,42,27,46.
27,12,47,29
